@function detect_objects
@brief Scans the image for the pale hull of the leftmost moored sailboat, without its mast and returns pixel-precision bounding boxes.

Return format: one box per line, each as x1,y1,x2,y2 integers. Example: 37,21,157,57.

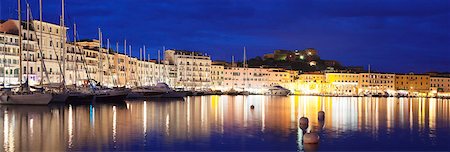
0,93,52,105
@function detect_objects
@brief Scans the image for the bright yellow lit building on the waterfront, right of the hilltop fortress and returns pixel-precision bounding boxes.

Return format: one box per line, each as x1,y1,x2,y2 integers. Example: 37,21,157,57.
325,73,360,95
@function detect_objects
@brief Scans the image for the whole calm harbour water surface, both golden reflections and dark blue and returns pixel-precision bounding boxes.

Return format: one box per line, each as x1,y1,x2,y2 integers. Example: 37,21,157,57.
0,95,450,151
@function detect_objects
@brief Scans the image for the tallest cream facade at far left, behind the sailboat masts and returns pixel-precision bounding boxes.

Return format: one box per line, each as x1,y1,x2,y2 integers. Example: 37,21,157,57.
0,19,67,84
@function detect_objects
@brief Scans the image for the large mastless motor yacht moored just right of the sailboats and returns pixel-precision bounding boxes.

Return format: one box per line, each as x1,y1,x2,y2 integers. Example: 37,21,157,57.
128,83,187,98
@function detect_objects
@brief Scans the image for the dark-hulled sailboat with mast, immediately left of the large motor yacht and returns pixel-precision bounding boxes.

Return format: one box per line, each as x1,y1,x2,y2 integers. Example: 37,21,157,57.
90,28,130,102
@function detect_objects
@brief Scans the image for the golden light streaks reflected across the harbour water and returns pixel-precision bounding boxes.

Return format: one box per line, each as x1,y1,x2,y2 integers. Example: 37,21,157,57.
0,96,450,151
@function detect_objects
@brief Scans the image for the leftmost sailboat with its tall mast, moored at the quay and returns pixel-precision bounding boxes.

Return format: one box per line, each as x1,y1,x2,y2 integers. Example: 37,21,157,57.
0,0,52,105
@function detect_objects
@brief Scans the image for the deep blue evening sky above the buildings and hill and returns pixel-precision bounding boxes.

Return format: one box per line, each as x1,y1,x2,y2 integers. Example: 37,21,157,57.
0,0,450,72
